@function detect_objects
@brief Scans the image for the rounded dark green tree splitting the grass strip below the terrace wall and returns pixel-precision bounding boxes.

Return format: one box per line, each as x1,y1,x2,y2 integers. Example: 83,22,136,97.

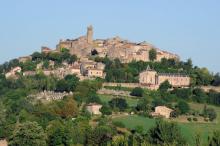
109,98,128,111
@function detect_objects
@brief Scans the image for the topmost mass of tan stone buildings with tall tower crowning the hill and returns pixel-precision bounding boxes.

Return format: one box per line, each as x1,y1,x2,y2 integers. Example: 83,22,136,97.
57,26,179,63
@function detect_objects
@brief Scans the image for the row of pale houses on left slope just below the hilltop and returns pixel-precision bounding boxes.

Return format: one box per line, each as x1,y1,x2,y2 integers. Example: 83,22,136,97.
5,59,105,80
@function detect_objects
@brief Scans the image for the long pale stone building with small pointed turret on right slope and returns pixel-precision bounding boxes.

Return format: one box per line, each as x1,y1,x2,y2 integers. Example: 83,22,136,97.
139,67,190,87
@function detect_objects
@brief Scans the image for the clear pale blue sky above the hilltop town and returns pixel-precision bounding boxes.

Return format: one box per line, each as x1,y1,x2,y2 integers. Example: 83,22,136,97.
0,0,220,72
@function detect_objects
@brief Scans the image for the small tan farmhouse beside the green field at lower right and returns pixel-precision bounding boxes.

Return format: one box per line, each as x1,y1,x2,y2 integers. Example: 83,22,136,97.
151,106,174,118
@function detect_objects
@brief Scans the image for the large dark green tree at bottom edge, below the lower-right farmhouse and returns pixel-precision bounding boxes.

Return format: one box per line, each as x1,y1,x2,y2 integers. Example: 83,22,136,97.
148,120,186,146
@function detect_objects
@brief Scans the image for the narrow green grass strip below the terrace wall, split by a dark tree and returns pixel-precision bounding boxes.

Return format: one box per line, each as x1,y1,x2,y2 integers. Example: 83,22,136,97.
99,95,139,107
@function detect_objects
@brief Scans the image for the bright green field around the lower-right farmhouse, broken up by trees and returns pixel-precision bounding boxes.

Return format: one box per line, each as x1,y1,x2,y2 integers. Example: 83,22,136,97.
113,103,220,145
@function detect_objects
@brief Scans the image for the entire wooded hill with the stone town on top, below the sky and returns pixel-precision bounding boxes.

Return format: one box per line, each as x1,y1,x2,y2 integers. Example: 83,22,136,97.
0,26,220,146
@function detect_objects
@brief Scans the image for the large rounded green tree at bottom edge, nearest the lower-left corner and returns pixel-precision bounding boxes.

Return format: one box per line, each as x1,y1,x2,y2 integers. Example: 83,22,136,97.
9,122,46,146
